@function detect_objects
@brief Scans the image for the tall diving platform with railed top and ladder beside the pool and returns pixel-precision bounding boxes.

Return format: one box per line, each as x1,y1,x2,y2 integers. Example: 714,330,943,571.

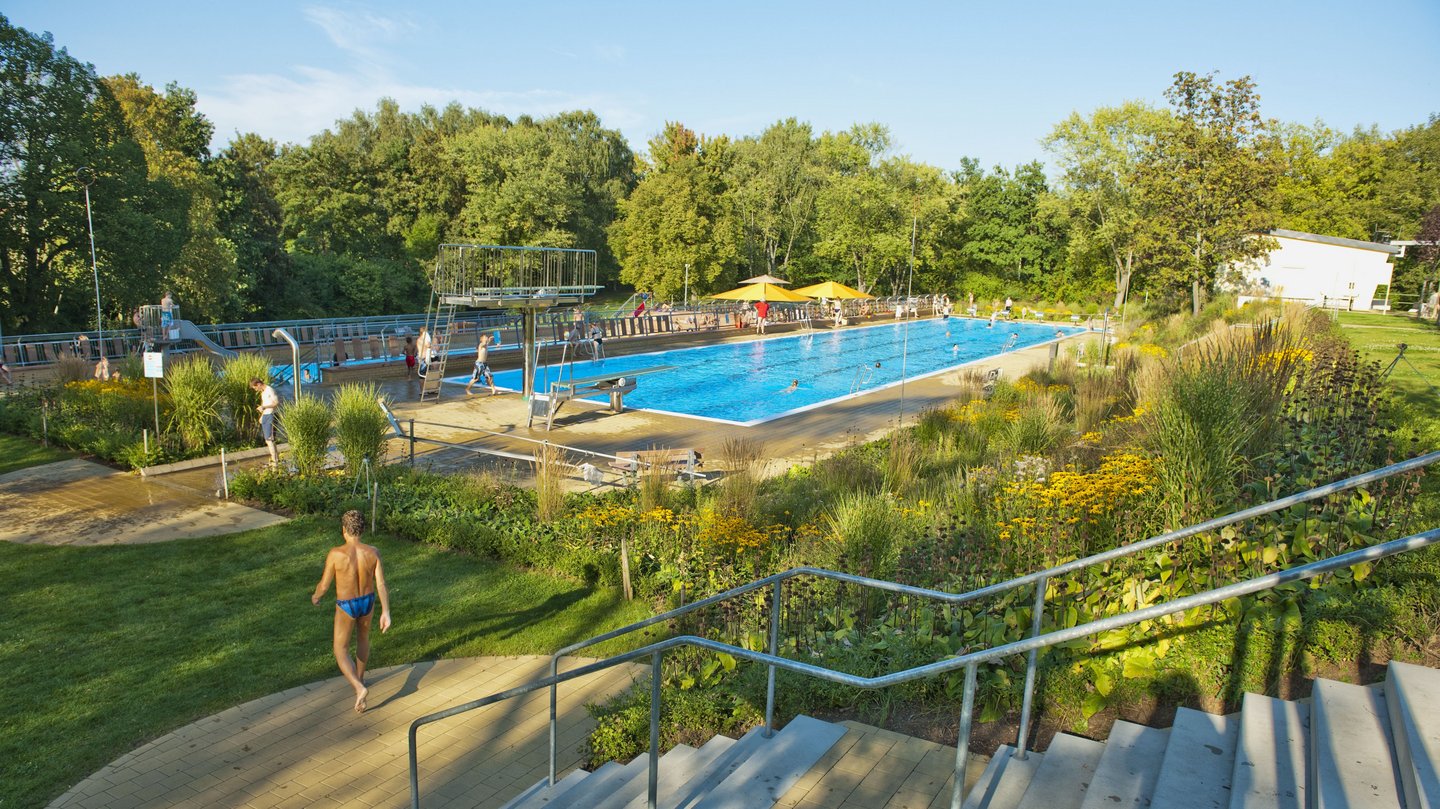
420,245,600,402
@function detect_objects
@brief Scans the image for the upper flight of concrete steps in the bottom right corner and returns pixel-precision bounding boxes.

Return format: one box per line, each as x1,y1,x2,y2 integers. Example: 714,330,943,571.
965,662,1440,809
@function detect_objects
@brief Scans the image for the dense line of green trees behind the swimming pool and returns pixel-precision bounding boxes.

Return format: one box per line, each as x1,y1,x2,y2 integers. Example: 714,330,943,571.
0,11,1440,333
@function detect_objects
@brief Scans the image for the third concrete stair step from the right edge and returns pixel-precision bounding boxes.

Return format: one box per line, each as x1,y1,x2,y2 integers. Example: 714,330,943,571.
1230,685,1310,809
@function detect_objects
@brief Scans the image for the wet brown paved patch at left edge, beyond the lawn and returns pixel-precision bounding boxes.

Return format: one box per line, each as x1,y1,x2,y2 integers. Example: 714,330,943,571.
0,459,285,546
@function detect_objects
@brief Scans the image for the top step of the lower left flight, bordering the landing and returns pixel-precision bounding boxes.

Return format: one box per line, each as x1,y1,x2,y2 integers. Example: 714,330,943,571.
694,714,845,809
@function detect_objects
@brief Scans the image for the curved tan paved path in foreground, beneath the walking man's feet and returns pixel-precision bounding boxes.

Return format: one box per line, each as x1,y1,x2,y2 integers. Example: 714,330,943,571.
50,656,647,809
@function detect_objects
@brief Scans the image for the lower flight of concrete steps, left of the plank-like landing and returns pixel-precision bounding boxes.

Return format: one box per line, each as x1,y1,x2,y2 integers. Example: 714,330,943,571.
504,715,845,809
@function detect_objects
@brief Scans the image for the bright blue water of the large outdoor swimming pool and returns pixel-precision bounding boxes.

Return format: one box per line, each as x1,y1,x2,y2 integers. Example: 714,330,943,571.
446,318,1084,426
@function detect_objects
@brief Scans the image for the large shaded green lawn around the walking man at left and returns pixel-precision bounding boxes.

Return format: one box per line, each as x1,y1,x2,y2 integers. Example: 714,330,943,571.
0,518,649,808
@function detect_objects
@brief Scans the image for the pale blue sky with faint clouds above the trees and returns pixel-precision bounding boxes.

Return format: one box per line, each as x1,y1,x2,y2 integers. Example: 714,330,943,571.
11,0,1440,168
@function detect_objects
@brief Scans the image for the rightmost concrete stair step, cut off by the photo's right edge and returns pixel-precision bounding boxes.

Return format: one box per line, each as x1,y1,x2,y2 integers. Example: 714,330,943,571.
1385,661,1440,809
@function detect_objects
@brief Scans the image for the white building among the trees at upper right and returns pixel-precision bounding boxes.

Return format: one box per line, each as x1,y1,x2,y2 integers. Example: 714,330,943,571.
1236,230,1400,309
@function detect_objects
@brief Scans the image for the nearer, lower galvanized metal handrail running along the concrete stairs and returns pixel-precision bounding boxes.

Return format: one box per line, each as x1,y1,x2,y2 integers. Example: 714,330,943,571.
409,528,1440,809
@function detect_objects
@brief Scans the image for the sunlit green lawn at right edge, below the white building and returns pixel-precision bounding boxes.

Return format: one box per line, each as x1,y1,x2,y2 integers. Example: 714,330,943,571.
1339,312,1440,449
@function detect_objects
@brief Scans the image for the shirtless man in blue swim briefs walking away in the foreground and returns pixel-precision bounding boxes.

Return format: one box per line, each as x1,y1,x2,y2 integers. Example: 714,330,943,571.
310,508,390,714
